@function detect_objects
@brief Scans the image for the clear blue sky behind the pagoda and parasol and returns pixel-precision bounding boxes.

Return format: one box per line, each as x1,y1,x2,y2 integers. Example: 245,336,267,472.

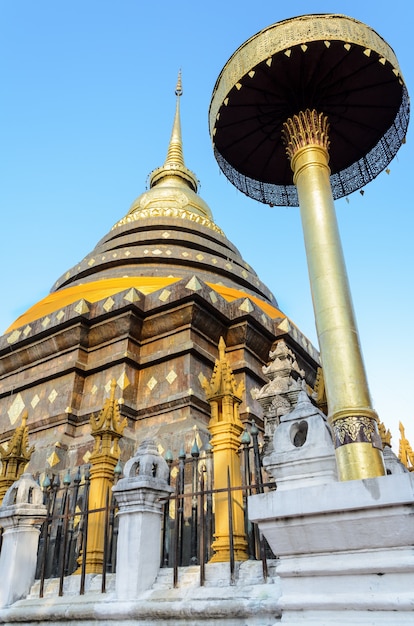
0,0,414,450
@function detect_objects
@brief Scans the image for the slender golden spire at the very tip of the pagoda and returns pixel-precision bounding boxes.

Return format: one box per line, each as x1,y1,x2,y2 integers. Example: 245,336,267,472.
150,70,198,192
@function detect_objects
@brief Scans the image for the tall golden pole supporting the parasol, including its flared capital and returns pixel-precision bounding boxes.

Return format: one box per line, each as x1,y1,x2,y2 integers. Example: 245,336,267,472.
282,109,385,480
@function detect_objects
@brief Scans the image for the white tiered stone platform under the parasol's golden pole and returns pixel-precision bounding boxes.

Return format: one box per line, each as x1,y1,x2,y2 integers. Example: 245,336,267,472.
249,473,414,626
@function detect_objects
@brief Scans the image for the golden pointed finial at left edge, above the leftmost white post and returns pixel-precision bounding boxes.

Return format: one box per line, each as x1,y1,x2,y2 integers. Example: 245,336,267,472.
0,411,34,504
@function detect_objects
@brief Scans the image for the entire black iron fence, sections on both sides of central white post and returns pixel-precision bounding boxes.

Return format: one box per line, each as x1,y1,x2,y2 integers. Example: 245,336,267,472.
0,425,275,597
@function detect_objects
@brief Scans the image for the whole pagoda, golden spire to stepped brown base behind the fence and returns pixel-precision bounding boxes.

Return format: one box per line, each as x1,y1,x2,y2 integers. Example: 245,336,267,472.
0,74,319,473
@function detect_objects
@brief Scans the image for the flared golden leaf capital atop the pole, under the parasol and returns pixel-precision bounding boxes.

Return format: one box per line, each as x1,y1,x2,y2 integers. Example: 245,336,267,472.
282,109,329,159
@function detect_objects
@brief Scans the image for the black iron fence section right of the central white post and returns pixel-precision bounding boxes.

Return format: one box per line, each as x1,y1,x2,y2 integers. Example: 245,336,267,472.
161,428,275,586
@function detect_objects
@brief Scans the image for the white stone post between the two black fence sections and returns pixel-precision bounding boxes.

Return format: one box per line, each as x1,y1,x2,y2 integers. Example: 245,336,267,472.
113,439,173,600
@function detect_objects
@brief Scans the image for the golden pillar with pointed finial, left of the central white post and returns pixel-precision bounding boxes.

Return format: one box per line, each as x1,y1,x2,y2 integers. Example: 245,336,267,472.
77,380,127,574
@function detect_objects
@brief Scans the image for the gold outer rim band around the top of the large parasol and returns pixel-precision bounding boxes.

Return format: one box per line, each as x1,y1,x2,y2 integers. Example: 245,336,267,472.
209,14,403,135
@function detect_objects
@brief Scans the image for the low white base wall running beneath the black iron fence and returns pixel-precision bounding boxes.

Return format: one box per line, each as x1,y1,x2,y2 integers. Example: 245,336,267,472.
6,561,281,626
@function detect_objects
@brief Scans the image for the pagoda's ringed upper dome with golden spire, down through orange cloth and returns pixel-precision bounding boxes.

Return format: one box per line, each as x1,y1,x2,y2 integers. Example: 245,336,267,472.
9,76,277,330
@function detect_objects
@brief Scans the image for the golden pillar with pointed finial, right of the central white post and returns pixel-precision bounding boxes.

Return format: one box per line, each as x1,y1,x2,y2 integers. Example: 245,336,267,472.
203,337,249,562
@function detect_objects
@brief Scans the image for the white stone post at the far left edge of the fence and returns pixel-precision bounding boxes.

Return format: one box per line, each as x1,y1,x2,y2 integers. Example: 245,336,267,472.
0,474,46,608
